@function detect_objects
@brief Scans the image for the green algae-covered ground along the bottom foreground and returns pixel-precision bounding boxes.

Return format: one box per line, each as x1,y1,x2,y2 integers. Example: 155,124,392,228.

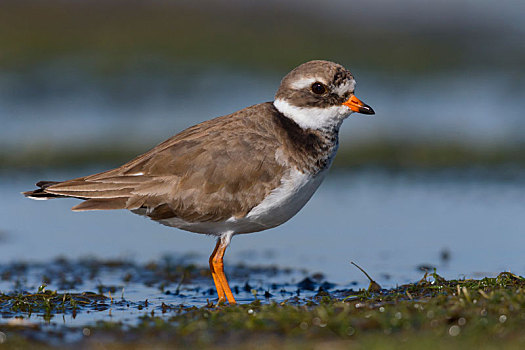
0,266,525,349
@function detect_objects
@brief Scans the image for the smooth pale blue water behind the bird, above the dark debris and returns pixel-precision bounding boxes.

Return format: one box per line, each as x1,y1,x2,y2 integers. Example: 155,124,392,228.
0,170,525,286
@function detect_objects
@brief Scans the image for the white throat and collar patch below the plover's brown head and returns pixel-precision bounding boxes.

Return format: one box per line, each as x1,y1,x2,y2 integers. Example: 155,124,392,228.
273,99,352,130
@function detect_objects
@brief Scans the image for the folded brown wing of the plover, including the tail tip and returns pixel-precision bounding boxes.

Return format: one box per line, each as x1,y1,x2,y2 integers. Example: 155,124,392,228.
24,106,284,222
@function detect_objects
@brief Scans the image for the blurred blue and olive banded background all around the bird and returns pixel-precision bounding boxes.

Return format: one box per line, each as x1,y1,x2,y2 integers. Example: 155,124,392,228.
0,0,525,285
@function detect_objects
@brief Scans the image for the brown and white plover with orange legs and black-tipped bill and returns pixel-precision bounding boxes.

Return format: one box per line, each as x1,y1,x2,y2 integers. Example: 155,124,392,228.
24,61,374,304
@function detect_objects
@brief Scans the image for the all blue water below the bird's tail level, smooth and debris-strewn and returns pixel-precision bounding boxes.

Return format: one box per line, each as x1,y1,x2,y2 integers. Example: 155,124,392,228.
0,169,525,334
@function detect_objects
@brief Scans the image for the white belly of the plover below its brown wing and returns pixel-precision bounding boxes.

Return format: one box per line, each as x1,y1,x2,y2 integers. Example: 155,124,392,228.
149,169,328,236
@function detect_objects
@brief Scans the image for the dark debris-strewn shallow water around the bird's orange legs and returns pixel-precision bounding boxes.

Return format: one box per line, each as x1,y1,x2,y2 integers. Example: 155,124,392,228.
0,257,320,330
